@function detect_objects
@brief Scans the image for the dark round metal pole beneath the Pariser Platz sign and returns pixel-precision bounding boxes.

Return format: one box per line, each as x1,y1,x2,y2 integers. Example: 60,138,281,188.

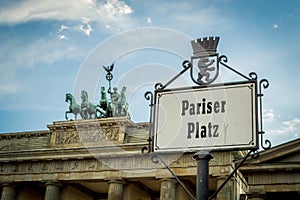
193,151,213,200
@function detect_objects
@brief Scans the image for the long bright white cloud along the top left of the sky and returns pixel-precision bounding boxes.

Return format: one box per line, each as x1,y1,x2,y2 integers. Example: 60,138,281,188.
0,0,133,30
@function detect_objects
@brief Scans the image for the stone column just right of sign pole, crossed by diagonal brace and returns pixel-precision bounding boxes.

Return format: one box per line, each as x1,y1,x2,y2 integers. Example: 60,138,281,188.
217,176,236,200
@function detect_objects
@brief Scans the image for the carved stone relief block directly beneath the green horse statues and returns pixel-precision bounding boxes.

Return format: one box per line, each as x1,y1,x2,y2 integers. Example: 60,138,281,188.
48,118,133,147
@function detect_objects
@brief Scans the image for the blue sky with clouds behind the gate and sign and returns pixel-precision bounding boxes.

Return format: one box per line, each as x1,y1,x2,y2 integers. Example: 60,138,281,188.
0,0,300,145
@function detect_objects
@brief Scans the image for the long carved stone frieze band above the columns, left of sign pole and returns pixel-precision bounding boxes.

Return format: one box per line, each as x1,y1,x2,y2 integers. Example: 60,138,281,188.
0,152,195,175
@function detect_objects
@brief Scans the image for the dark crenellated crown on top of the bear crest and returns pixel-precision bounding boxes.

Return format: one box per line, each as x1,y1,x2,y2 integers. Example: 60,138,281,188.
191,37,220,57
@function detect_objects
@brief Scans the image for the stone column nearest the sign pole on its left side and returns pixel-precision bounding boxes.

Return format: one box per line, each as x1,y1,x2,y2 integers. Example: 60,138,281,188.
160,179,176,200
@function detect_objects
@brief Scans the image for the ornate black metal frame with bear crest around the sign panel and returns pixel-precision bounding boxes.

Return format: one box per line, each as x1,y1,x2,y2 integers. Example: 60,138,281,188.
142,37,271,153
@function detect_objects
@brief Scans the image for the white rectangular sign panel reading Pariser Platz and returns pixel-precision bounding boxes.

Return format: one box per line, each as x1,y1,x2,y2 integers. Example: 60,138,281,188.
154,81,258,151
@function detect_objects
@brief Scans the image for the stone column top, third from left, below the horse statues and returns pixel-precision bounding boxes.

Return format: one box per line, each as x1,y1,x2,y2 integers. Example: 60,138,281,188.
107,180,125,200
